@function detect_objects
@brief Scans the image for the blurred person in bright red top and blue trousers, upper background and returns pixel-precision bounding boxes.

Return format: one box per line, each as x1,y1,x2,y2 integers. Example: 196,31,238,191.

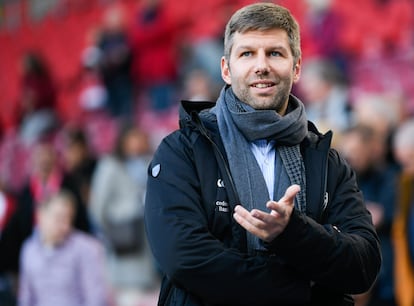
130,0,178,113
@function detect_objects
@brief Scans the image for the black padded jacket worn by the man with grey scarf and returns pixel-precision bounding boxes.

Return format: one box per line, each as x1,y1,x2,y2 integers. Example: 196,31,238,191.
145,102,381,306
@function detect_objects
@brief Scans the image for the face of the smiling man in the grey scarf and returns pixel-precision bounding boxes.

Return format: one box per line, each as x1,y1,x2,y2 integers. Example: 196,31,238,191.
221,29,301,115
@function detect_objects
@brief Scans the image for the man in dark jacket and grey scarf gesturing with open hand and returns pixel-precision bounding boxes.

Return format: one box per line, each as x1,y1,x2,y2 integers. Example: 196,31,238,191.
145,3,381,306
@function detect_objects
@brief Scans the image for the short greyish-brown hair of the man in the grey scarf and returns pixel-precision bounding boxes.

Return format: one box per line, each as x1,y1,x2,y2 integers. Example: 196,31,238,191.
224,3,301,64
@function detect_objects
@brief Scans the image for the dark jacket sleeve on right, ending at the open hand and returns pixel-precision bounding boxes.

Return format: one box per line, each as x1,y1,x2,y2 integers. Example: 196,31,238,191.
271,150,381,294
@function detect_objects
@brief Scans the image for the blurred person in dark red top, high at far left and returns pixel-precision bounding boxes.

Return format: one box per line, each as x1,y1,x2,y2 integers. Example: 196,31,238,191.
17,52,58,145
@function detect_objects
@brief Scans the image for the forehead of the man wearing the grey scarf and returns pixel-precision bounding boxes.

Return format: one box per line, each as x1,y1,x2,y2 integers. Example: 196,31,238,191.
232,28,290,51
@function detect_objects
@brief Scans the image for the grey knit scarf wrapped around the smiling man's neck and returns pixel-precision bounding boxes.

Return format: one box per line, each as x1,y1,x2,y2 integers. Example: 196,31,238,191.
211,86,307,251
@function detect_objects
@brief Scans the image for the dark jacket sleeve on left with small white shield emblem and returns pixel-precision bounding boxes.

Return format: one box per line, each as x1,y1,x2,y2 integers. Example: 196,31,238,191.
145,133,310,305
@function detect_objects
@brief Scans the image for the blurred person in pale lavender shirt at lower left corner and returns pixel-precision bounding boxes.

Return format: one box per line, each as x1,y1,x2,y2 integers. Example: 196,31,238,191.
18,191,110,306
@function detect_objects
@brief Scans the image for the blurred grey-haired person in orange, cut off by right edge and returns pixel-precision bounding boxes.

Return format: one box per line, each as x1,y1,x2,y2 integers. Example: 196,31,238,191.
393,118,414,306
